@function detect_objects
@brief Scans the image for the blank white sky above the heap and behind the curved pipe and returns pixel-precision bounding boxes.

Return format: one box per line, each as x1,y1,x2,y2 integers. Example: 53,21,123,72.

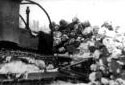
20,0,125,32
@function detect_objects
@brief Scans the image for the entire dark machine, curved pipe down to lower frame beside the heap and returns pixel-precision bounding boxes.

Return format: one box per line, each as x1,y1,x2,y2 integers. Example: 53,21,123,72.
0,0,92,85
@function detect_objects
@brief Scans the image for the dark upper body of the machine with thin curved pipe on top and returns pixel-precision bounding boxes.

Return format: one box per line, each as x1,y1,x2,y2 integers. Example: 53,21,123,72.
0,0,53,55
